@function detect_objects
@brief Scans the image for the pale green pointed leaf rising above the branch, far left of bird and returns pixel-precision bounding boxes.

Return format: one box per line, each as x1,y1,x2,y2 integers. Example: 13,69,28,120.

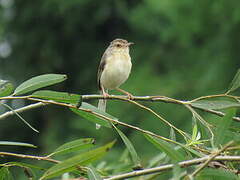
13,74,67,95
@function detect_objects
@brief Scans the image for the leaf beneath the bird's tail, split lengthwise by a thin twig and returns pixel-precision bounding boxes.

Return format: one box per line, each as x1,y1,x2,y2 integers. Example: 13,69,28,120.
70,102,118,128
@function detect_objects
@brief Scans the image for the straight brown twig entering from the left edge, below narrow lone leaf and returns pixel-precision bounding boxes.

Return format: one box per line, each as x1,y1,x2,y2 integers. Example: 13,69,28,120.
0,152,61,163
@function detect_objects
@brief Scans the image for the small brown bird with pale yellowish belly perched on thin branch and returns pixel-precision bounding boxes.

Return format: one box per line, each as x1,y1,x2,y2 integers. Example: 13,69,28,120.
96,38,134,129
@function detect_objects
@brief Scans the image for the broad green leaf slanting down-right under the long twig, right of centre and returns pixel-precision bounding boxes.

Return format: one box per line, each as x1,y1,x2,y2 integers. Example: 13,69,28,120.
144,134,185,162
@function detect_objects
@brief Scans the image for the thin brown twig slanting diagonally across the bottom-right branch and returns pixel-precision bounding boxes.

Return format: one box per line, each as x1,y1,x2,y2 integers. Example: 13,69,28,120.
189,141,233,179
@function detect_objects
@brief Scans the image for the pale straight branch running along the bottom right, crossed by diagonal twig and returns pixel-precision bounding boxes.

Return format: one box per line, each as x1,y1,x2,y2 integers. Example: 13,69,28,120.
104,155,240,180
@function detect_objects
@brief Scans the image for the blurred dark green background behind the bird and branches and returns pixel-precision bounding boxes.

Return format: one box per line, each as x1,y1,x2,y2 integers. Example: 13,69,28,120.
0,0,240,177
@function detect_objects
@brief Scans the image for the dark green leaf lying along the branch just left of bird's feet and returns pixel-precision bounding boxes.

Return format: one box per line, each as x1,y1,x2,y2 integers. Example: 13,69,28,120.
31,90,81,104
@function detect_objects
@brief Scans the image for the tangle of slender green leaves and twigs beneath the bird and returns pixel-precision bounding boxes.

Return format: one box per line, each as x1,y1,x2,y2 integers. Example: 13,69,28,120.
0,73,240,180
